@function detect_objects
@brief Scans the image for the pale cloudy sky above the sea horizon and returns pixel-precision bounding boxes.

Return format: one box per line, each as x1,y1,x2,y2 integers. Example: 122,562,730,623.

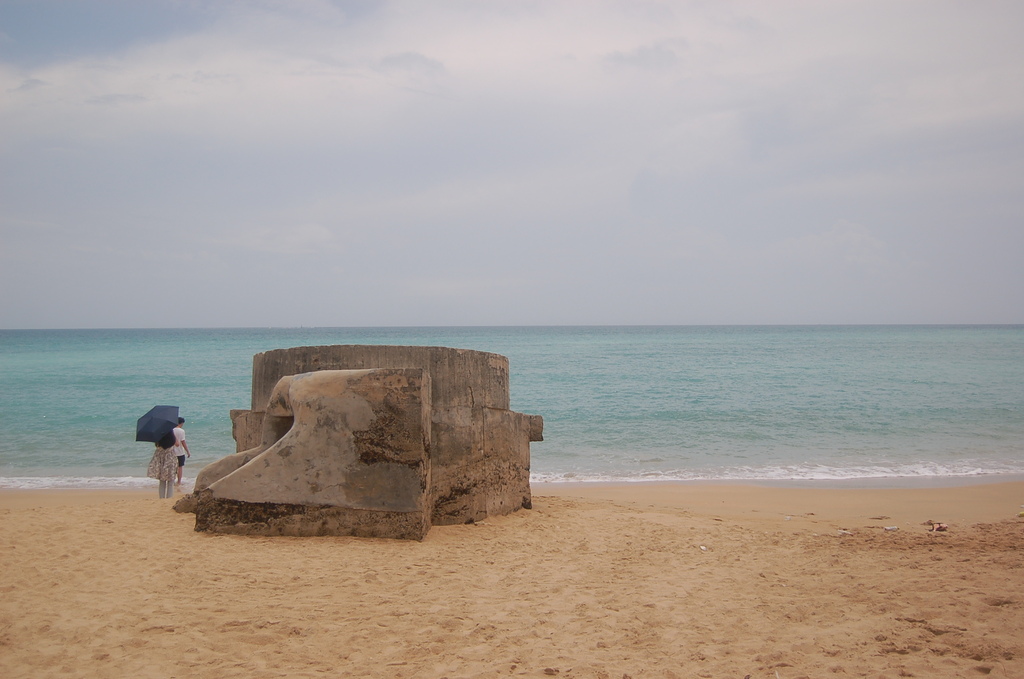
0,0,1024,329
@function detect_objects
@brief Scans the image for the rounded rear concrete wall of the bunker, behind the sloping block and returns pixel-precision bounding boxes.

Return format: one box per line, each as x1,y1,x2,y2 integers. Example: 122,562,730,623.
227,345,544,524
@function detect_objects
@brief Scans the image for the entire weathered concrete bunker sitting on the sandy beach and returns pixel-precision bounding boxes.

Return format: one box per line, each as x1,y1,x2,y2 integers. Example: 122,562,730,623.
189,345,544,540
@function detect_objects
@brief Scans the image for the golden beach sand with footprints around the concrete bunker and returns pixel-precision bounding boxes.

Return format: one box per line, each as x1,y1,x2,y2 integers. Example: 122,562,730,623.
0,481,1024,679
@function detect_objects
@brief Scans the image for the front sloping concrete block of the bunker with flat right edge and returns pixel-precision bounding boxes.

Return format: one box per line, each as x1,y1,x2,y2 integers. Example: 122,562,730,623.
194,368,431,539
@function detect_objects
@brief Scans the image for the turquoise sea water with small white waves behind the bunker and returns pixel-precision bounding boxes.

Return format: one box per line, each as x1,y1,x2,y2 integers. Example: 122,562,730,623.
0,326,1024,489
